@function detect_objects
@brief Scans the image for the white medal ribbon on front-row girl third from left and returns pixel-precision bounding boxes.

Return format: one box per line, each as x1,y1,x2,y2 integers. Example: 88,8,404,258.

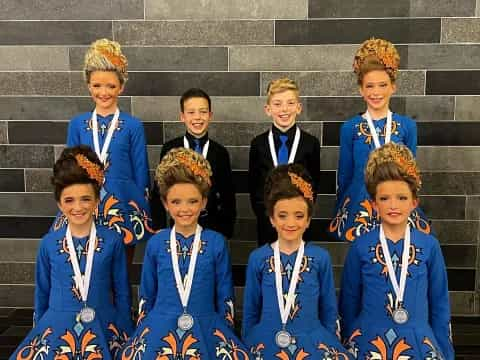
272,240,305,326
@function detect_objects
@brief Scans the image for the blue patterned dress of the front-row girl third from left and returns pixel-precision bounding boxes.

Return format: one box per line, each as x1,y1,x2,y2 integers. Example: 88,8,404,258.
242,243,350,360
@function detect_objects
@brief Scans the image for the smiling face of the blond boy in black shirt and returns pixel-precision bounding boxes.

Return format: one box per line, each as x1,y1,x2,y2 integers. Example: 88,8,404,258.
265,90,302,132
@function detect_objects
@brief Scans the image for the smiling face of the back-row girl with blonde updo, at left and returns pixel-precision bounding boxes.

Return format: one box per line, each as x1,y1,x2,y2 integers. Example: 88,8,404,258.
88,71,123,116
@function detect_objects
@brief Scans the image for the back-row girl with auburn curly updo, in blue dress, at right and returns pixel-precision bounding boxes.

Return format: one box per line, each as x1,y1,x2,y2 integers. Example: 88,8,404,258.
329,39,431,241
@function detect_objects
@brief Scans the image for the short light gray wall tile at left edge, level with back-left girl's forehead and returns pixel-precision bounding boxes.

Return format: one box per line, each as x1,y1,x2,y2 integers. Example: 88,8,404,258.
0,72,70,95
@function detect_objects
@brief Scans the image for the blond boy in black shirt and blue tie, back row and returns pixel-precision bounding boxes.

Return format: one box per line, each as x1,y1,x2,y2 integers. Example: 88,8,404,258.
248,78,320,246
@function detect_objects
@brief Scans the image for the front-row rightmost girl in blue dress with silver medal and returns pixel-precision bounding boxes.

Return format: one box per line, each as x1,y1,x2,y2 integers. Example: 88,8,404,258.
340,143,454,360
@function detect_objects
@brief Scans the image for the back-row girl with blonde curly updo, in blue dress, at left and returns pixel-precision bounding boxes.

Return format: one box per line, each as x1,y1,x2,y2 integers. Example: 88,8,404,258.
53,39,153,263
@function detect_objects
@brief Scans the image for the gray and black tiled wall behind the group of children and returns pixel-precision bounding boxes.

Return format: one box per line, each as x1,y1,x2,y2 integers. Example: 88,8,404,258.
0,0,480,315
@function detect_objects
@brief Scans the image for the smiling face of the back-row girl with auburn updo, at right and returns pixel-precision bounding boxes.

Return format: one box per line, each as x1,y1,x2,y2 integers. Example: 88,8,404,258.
359,70,396,118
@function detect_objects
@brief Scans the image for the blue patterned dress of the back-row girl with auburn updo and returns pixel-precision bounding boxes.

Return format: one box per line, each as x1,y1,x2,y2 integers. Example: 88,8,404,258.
329,113,431,241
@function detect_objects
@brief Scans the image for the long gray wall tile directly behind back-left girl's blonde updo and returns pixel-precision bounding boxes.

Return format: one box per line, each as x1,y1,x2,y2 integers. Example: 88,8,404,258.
70,46,228,71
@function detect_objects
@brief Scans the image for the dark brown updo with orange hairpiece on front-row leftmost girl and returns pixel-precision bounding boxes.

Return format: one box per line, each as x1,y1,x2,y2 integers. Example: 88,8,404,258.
51,145,104,202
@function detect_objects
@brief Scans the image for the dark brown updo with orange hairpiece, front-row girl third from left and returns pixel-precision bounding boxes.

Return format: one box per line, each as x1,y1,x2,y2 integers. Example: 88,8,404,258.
264,164,314,217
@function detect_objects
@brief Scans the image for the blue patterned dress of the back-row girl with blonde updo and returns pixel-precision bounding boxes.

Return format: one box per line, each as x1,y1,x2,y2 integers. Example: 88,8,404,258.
52,112,154,245
